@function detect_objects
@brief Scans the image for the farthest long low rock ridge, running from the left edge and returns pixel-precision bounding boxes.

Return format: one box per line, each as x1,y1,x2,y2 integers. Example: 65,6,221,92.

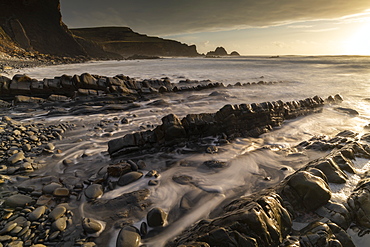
0,73,281,103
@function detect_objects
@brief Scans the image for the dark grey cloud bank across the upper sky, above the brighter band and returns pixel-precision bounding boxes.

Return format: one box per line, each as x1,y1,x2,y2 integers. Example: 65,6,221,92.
61,0,370,35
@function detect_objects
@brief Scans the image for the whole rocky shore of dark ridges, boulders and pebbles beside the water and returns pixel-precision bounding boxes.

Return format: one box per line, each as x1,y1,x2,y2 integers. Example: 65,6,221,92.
0,68,370,247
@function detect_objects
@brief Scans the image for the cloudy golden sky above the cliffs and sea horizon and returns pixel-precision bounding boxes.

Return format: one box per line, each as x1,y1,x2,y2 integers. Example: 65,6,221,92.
60,0,370,55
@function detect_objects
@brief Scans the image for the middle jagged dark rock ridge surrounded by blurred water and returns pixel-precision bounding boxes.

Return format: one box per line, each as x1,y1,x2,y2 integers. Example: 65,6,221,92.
108,96,324,156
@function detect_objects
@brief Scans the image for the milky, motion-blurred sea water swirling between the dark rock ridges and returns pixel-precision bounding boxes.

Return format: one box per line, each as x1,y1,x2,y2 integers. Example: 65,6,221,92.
13,56,370,246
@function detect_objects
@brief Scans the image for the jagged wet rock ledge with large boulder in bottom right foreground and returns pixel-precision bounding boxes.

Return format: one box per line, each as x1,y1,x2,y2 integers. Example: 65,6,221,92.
168,141,370,247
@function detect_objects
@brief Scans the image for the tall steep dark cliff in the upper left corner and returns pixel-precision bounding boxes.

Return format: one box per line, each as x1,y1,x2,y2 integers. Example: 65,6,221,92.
0,0,87,57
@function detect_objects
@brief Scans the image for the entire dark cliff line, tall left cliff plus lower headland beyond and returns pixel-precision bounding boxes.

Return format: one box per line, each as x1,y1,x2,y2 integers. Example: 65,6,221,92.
0,0,199,59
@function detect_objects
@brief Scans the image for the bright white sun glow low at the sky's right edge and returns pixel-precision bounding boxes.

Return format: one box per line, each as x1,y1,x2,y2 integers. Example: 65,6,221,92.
345,19,370,56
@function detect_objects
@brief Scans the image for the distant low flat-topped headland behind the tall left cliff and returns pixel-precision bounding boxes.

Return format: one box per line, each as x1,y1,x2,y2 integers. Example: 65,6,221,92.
71,27,199,57
